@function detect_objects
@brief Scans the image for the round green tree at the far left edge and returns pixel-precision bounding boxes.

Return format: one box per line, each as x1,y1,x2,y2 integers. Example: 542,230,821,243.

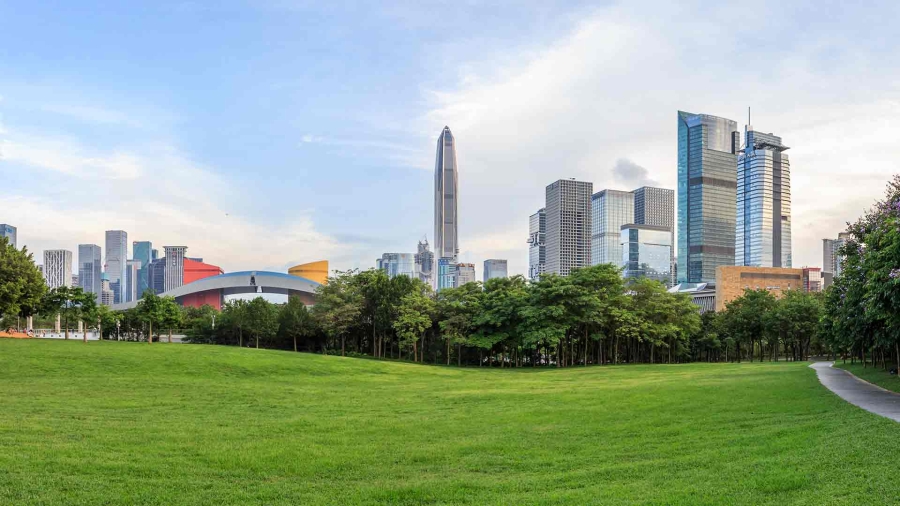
0,237,47,322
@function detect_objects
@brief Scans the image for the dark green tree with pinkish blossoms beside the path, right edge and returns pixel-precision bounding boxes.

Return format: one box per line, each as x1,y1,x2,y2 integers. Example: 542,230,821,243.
822,175,900,368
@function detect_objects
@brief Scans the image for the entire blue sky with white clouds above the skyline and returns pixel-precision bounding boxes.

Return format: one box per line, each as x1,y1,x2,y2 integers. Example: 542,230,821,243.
0,0,900,273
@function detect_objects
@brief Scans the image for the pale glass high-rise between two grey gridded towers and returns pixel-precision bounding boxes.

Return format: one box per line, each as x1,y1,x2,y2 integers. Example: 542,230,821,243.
591,190,634,267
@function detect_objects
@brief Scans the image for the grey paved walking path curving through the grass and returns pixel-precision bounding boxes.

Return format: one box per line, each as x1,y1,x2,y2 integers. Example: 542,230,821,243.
810,362,900,422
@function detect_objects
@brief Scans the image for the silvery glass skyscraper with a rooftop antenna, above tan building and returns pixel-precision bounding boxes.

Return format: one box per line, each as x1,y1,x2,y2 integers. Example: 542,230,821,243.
734,125,792,268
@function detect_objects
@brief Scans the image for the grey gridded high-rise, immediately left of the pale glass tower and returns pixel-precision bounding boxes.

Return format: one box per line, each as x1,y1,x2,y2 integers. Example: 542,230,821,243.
544,179,594,276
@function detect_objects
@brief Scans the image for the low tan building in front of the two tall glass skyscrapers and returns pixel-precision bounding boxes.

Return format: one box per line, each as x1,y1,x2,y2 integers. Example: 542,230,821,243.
716,265,803,311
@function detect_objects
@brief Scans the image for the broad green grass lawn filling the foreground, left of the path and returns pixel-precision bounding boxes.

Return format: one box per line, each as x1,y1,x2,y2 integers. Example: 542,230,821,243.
0,339,900,506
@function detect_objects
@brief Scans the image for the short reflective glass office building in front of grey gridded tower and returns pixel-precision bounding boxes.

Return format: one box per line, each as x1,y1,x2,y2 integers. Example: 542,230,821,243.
620,224,672,286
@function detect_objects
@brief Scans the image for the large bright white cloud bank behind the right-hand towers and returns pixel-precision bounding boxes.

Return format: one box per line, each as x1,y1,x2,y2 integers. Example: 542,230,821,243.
423,2,900,273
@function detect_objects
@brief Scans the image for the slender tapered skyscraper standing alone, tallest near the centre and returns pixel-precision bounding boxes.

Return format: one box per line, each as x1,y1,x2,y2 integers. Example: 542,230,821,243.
434,126,459,258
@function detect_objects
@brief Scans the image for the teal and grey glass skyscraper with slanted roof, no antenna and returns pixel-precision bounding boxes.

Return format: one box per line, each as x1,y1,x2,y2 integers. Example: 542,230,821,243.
678,111,741,283
